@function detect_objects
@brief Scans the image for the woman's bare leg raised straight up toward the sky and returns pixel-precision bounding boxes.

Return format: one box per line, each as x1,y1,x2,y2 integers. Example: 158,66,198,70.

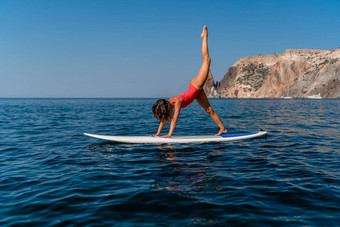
191,26,210,89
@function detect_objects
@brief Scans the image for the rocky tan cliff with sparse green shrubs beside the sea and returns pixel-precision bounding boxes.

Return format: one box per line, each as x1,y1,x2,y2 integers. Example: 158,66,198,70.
212,49,340,98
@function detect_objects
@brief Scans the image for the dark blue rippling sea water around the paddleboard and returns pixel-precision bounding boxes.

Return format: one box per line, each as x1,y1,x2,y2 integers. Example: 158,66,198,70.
0,99,340,226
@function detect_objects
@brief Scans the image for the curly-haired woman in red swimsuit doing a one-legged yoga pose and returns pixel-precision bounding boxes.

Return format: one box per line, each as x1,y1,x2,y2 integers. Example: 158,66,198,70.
152,26,227,138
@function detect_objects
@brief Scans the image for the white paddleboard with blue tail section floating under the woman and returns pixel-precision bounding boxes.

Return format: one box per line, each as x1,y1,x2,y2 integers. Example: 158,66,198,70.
84,131,267,144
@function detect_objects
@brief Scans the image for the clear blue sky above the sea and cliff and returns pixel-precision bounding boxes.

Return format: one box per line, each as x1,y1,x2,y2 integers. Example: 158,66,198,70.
0,0,340,97
